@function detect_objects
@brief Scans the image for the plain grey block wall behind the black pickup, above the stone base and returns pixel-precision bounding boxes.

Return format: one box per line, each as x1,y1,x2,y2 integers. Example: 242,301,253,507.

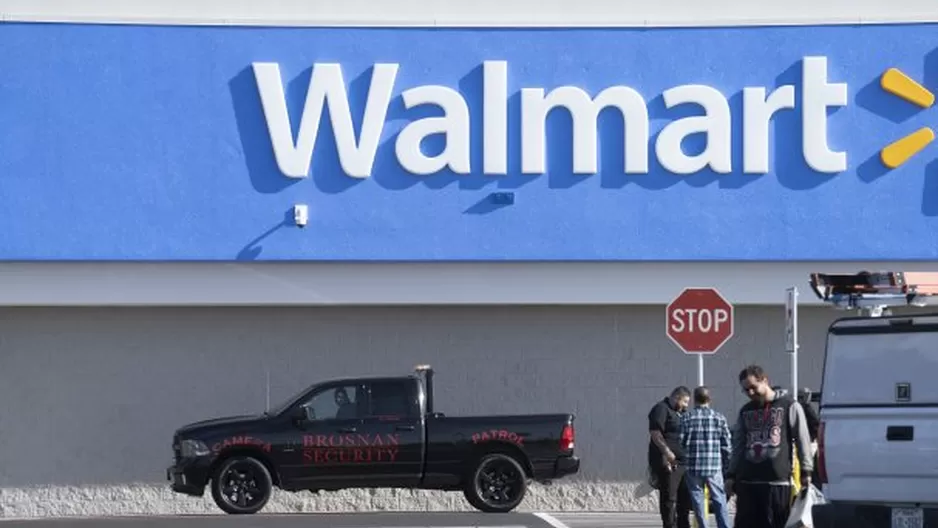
0,306,841,516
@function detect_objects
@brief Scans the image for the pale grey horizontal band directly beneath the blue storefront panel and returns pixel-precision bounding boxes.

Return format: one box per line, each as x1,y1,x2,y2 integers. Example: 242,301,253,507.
0,262,938,306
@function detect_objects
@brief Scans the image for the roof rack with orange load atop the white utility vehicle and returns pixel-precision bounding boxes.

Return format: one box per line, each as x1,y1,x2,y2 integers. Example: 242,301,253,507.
809,271,938,317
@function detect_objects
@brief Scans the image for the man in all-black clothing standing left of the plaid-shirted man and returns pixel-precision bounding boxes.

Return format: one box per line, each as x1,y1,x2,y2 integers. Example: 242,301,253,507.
648,386,691,528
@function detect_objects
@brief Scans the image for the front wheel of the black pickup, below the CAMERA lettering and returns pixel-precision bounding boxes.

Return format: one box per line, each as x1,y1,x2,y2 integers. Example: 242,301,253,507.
212,456,273,514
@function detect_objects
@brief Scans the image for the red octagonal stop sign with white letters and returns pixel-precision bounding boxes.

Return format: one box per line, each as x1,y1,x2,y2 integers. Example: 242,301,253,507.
667,288,733,354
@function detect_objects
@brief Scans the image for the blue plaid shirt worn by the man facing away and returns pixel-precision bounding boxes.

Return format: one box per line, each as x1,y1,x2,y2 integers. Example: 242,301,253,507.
681,407,732,477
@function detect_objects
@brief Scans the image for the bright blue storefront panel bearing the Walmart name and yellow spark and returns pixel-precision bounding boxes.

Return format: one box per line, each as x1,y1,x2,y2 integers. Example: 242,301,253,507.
0,24,938,260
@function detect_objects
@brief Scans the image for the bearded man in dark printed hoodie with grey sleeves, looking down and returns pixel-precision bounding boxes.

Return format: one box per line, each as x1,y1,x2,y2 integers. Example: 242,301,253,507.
726,365,814,528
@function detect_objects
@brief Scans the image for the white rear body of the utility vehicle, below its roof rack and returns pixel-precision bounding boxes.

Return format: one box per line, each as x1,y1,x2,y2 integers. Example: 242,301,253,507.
820,315,938,504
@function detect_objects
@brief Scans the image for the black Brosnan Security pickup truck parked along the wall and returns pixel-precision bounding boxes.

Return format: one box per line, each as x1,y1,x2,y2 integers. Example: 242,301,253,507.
166,366,580,514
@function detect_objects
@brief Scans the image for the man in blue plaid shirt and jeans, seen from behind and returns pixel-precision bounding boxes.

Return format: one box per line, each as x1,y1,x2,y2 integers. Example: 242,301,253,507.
681,387,732,528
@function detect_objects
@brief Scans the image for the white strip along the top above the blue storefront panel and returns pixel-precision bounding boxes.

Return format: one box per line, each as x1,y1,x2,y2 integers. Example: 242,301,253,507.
0,0,938,27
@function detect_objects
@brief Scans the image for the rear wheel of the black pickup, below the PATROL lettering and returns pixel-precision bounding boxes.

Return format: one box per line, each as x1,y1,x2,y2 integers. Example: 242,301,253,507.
463,453,528,513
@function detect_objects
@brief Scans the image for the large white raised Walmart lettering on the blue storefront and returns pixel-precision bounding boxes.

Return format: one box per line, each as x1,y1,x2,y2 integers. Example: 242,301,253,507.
253,57,847,178
